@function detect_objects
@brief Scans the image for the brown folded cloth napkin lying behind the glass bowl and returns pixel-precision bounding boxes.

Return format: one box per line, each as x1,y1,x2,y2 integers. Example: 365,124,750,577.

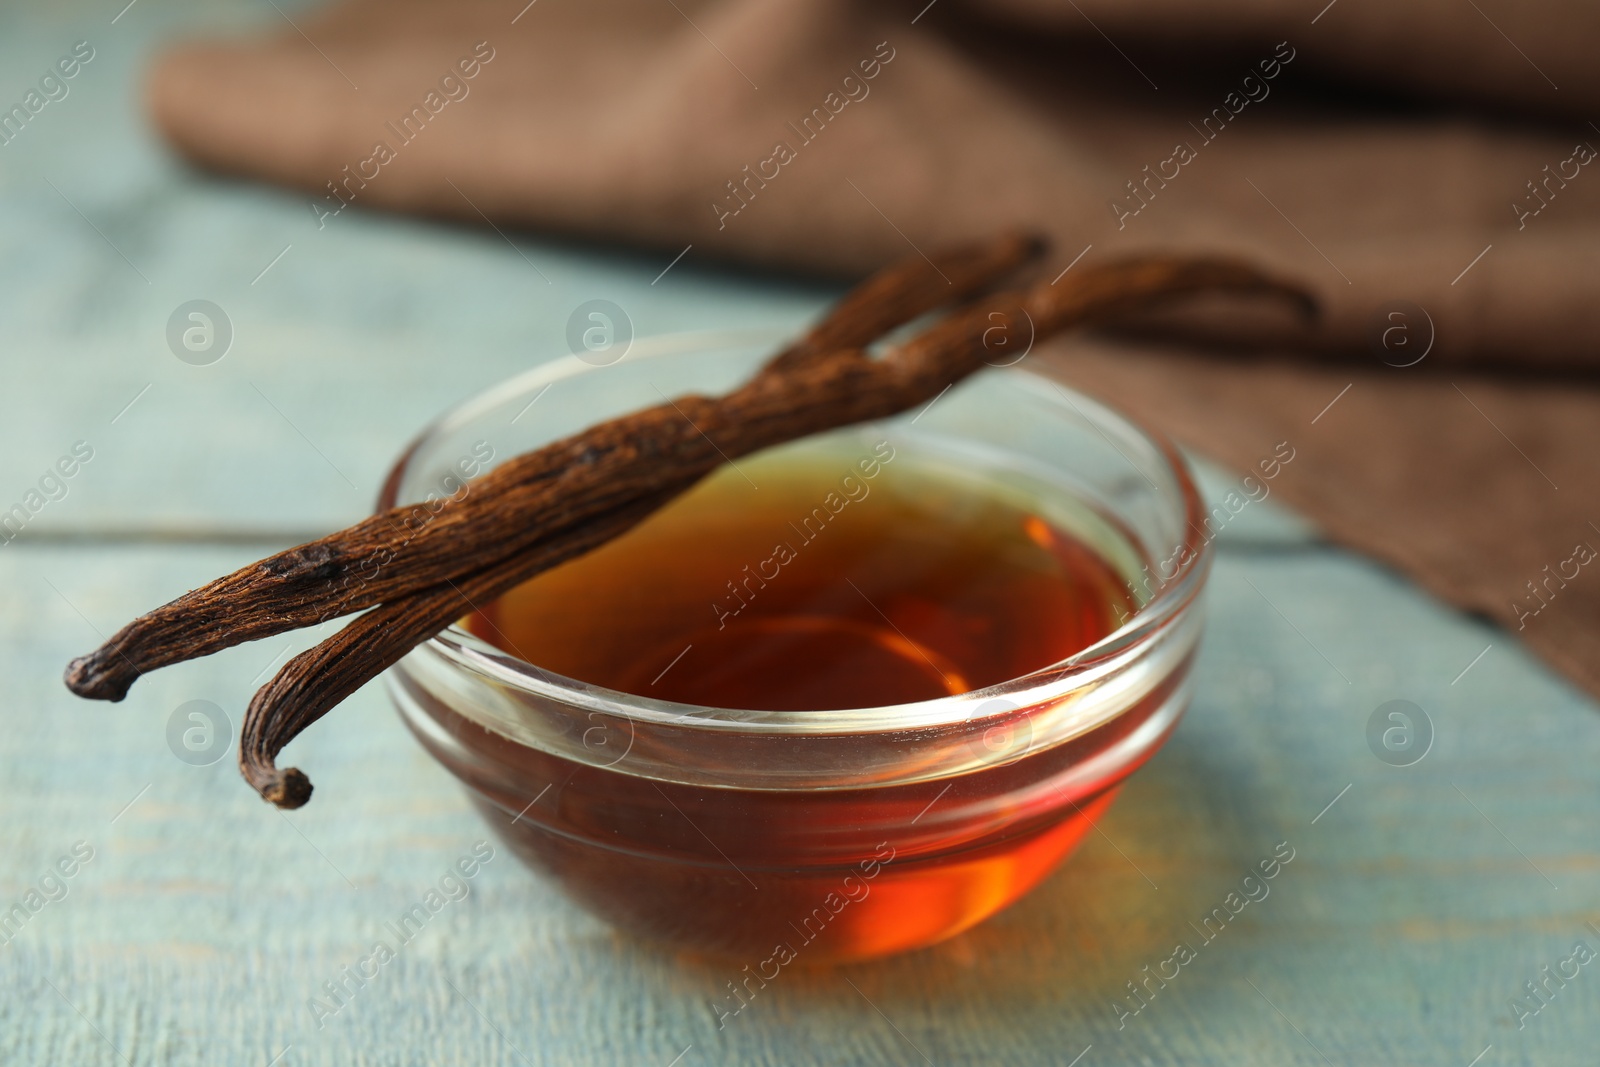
150,0,1600,696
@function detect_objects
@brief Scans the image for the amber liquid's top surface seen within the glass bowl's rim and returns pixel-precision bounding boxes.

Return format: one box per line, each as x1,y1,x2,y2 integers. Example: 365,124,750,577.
466,445,1134,710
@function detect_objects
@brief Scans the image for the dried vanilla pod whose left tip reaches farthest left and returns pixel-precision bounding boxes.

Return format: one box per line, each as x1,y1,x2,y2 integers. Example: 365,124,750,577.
66,232,1043,701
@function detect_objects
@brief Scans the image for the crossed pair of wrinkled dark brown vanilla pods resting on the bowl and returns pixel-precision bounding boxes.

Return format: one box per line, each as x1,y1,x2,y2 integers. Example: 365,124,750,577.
66,234,1315,808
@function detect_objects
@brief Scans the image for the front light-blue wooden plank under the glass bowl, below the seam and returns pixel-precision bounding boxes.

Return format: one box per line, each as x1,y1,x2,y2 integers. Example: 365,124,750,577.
0,545,1600,1065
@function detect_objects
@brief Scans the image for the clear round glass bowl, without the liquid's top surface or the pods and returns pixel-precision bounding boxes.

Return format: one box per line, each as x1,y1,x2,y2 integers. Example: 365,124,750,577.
381,331,1210,974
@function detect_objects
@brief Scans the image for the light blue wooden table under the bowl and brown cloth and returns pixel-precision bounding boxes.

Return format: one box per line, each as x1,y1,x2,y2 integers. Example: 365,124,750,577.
0,0,1600,1067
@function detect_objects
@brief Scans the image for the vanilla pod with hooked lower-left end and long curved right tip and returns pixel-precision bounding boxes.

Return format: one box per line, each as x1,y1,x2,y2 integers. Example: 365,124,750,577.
240,258,1315,808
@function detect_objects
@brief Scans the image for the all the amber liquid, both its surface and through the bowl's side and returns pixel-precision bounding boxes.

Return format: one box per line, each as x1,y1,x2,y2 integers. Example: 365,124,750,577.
419,438,1187,959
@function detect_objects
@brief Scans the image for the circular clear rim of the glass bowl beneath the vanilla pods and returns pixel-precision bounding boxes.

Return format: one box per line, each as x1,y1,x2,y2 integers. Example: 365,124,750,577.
378,328,1213,734
